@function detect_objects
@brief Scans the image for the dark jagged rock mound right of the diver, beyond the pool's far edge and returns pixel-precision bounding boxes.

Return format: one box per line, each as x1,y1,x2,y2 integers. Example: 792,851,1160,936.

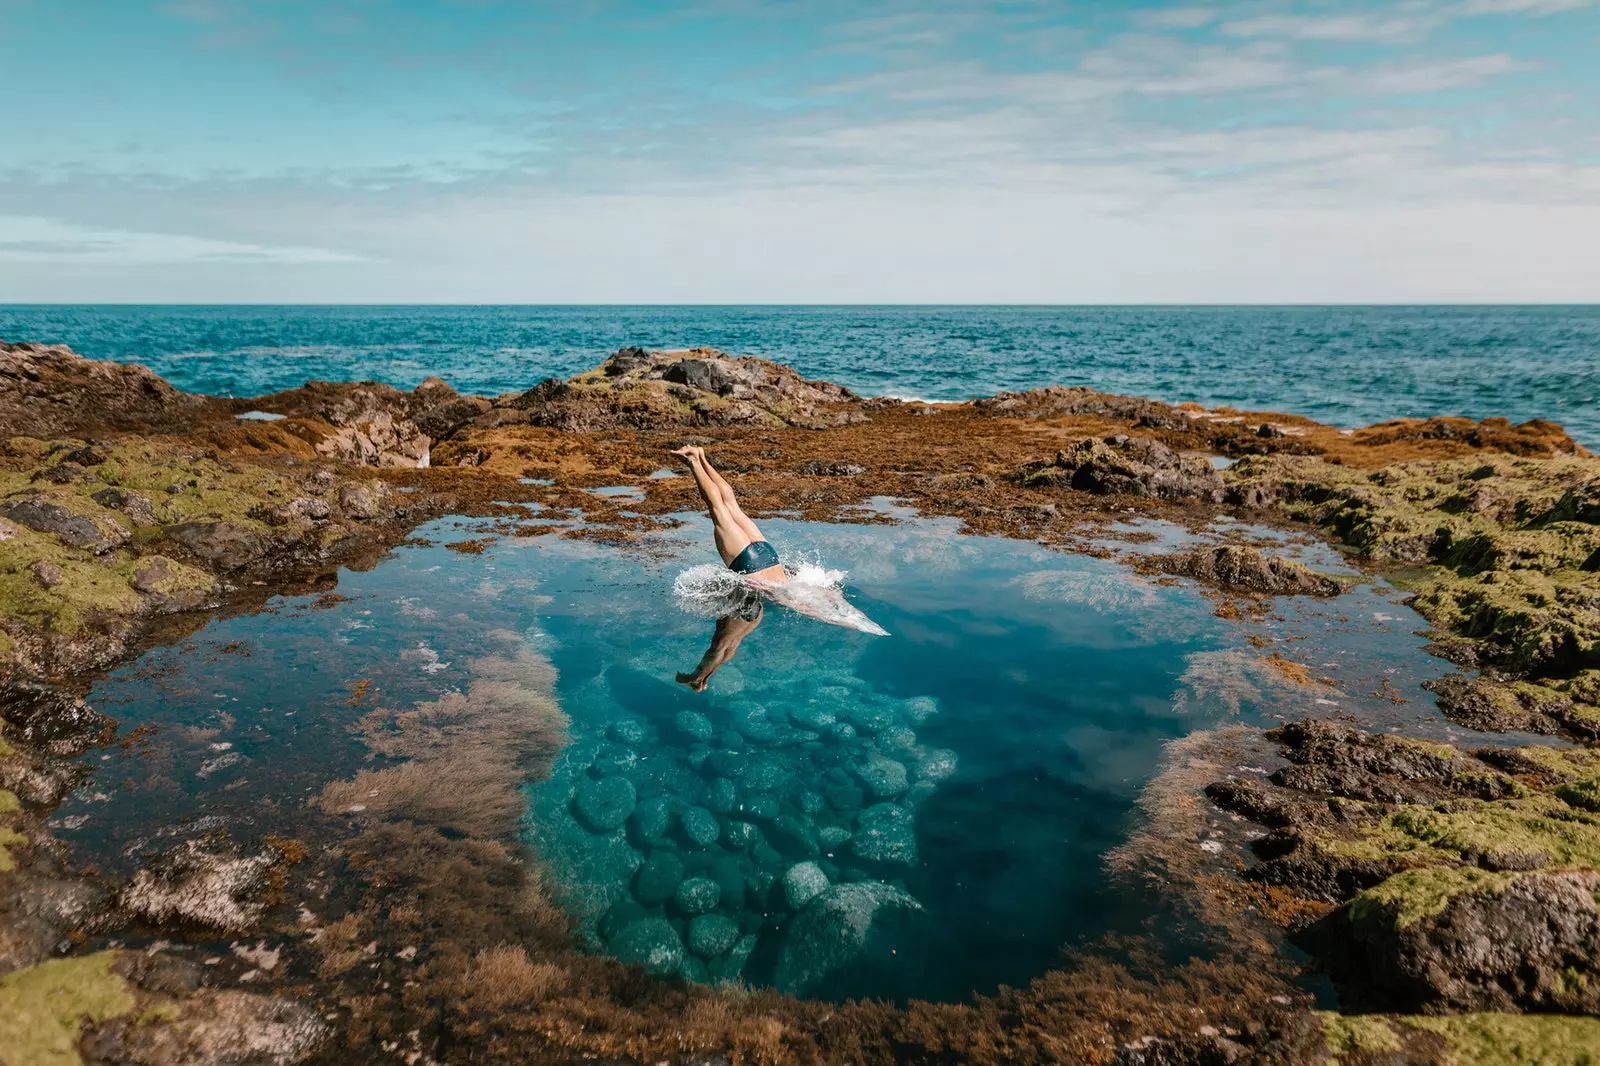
1018,434,1222,503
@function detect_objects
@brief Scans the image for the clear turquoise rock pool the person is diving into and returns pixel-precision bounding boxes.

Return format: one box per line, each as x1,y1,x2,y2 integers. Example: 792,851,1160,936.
53,507,1450,999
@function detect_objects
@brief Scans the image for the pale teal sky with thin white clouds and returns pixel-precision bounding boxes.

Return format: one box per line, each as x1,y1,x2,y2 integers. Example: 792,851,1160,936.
0,0,1600,304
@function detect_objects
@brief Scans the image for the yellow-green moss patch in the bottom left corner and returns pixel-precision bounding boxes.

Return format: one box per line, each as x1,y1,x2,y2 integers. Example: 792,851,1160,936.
0,951,134,1066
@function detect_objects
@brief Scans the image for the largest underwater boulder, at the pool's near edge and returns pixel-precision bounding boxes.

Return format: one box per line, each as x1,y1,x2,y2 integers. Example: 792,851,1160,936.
773,880,926,996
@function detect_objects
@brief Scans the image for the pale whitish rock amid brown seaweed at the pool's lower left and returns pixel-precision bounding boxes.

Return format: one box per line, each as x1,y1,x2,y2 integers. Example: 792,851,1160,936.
117,840,282,933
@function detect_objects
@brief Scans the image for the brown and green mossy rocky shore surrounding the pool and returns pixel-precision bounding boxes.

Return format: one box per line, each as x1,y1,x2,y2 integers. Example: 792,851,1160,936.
0,344,1600,1063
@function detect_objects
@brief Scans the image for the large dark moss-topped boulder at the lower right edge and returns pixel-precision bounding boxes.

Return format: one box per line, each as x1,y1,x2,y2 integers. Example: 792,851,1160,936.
1315,868,1600,1013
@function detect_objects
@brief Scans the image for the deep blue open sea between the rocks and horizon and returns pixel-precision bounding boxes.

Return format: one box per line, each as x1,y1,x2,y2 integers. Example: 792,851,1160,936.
0,306,1600,448
